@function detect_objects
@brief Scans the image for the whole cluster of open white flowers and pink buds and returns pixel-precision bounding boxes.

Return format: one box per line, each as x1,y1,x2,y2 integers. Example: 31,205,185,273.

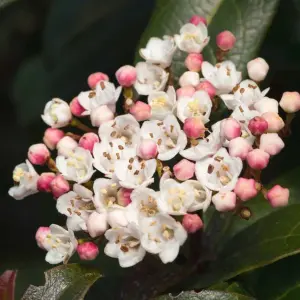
9,16,300,267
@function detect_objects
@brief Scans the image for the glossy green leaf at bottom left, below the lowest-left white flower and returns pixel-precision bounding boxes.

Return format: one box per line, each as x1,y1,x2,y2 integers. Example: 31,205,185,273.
22,264,101,300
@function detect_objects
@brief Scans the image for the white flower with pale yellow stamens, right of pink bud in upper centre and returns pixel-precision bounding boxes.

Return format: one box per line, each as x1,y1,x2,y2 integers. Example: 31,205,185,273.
148,86,176,120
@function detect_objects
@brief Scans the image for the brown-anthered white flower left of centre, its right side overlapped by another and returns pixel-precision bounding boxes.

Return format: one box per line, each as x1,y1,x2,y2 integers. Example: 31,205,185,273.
93,139,136,178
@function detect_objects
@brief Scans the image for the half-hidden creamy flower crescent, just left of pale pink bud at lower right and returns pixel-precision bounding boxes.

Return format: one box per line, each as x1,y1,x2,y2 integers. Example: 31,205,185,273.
186,180,212,212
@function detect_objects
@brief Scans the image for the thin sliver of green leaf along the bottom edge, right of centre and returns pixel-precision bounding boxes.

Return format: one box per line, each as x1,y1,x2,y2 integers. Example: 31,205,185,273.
156,290,254,300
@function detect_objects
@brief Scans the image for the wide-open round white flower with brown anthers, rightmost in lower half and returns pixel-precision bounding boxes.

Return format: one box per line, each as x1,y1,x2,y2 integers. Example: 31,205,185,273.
196,148,243,191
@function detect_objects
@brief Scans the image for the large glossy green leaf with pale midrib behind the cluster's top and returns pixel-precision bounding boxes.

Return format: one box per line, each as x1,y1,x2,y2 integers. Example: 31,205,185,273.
139,0,279,78
